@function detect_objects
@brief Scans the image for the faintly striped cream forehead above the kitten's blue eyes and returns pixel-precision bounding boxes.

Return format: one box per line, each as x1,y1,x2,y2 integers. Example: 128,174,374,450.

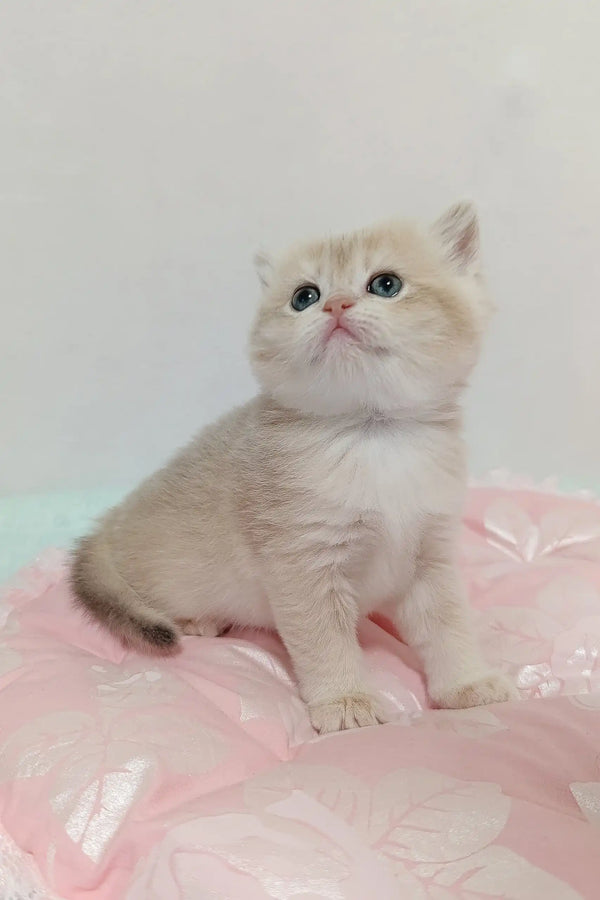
280,223,431,285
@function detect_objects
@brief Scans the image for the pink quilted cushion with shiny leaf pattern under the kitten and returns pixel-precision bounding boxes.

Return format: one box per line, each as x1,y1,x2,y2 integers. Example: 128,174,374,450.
0,488,600,900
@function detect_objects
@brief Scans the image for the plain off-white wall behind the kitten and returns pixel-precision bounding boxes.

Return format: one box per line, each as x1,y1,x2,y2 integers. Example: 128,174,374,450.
0,0,600,491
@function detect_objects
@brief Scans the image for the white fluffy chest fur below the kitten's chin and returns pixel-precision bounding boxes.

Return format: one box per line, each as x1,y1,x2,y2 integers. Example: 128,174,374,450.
282,416,463,613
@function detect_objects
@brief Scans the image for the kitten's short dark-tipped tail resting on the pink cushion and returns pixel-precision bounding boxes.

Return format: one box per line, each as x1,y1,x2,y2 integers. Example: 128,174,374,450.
70,534,179,656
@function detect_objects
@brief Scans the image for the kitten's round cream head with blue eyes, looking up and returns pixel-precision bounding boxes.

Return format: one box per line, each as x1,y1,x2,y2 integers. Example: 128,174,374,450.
250,205,491,415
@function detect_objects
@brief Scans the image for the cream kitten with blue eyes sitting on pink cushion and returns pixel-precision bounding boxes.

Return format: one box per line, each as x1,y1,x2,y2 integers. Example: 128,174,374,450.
72,205,514,732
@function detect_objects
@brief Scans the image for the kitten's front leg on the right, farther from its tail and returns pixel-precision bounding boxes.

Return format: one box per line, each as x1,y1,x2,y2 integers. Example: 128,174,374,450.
396,523,517,709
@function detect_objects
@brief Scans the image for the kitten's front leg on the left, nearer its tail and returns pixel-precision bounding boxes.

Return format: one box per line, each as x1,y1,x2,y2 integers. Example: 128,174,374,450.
271,571,388,734
